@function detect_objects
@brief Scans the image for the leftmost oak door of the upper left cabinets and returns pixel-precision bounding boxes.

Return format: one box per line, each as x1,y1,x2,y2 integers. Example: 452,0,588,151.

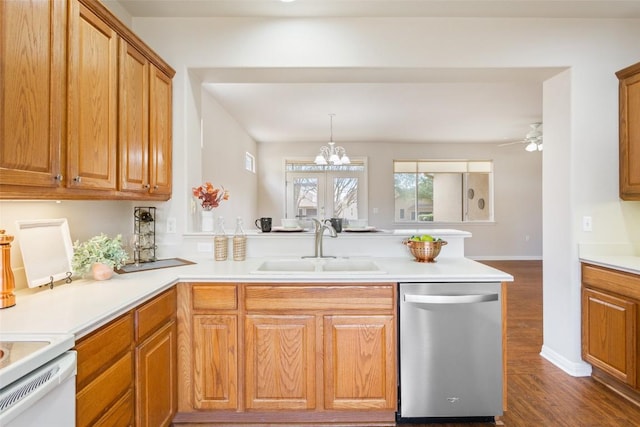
0,0,66,189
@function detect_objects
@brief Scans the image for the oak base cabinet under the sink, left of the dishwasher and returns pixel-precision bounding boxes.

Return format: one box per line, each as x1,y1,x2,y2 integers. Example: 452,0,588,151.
174,283,397,425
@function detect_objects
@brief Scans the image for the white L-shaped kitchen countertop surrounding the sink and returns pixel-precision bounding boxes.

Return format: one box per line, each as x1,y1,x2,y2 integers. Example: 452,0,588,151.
0,257,513,340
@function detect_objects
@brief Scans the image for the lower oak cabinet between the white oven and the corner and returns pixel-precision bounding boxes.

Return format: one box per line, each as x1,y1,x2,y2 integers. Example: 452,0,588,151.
75,289,177,427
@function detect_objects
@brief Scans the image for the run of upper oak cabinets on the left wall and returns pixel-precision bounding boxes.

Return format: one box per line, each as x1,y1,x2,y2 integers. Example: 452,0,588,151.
0,0,175,200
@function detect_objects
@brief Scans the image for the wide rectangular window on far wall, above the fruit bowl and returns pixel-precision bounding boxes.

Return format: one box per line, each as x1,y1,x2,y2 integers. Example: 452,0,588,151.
393,160,493,222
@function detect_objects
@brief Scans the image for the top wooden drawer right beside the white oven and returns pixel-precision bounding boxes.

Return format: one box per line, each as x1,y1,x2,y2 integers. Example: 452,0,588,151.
75,313,133,390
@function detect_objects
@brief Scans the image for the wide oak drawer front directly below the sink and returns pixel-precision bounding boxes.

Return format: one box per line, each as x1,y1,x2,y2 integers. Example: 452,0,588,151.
245,284,395,311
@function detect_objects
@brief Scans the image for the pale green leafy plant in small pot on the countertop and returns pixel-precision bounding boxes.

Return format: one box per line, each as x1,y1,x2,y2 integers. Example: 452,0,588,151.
71,233,129,274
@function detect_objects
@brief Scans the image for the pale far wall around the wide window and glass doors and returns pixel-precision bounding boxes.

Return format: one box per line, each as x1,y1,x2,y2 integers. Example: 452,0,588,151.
258,142,542,259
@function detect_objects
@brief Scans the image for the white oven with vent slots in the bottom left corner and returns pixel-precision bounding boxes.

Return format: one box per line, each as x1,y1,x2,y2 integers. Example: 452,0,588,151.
0,334,77,427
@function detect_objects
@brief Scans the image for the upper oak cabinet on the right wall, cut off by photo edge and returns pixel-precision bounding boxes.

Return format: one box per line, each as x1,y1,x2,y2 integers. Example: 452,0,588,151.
616,62,640,200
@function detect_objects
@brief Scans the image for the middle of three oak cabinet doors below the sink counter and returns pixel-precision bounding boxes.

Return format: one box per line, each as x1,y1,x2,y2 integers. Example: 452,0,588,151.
244,315,316,409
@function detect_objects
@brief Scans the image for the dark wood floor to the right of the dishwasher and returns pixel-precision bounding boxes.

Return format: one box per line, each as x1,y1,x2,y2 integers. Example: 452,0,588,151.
402,261,640,427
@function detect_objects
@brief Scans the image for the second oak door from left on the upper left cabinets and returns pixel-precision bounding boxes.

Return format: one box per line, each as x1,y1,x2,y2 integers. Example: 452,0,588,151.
67,0,118,190
